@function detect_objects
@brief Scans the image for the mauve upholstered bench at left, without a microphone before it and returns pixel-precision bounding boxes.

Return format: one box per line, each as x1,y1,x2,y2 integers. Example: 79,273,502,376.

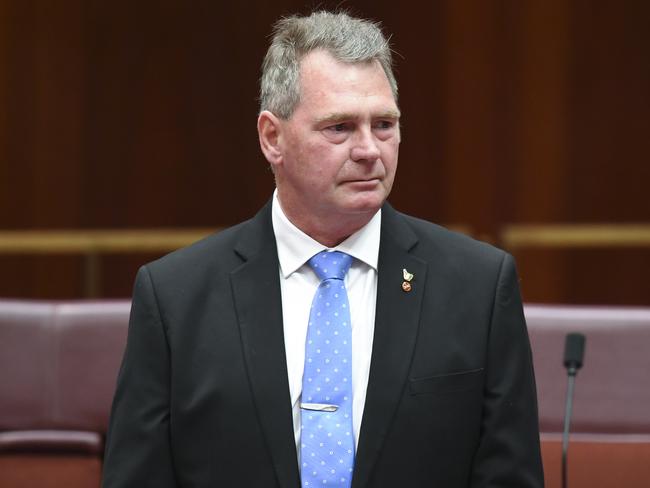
0,300,130,488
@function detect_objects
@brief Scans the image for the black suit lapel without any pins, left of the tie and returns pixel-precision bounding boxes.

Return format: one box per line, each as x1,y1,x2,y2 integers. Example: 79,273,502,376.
230,204,300,488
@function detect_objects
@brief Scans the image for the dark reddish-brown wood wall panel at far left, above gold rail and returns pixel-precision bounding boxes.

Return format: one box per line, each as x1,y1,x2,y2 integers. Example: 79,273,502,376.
0,1,85,228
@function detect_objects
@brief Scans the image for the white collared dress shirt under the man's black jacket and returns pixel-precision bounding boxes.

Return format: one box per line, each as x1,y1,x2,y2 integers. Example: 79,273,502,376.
272,190,381,452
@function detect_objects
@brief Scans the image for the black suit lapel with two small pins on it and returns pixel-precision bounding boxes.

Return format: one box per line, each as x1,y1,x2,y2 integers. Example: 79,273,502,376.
352,204,427,488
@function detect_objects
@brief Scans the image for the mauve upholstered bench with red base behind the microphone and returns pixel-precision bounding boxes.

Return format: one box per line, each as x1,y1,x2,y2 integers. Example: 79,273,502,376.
525,305,650,488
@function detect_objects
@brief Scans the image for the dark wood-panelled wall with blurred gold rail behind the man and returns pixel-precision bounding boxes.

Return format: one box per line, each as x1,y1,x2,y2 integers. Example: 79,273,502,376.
0,0,650,305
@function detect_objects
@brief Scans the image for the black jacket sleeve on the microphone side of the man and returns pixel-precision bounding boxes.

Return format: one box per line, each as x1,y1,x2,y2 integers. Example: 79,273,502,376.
471,254,544,488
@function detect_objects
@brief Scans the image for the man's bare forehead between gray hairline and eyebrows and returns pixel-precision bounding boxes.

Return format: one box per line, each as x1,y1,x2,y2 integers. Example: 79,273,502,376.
299,50,397,115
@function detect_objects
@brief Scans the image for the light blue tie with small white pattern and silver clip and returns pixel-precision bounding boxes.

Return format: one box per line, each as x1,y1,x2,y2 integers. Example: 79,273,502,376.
300,251,354,488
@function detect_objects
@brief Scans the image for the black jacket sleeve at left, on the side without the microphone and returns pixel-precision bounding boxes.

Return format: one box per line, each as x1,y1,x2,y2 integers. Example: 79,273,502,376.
102,267,177,488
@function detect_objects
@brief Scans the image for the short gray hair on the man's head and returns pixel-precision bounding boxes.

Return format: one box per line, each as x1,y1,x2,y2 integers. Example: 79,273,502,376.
260,11,397,120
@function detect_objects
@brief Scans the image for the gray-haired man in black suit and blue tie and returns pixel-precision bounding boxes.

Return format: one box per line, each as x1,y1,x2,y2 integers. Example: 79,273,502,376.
104,12,543,488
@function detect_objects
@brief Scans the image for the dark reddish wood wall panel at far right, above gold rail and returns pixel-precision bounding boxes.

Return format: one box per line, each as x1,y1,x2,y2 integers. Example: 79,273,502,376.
565,1,650,222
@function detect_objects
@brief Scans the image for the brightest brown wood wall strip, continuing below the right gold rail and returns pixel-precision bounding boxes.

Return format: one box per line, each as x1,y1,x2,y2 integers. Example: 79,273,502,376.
499,0,573,302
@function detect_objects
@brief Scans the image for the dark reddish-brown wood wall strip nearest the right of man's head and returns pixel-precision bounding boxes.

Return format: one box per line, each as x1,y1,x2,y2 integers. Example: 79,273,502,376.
442,2,503,233
